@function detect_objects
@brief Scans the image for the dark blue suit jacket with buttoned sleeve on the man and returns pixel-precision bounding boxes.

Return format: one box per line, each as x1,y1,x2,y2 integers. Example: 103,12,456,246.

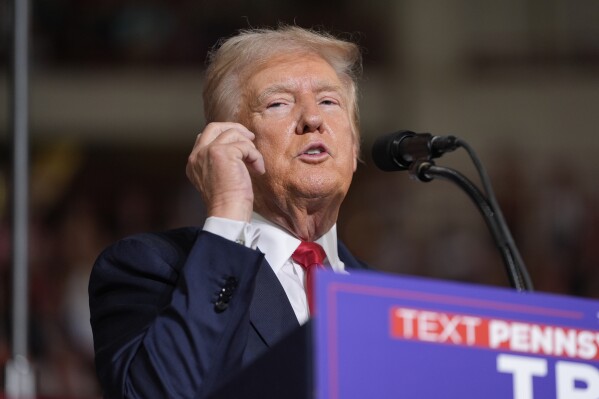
89,228,366,399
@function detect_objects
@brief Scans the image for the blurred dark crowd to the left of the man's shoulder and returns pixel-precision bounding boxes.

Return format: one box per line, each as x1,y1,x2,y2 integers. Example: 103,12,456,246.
0,143,202,398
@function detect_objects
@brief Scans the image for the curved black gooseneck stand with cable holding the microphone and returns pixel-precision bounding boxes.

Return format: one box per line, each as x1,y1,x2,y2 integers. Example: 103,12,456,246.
409,160,533,291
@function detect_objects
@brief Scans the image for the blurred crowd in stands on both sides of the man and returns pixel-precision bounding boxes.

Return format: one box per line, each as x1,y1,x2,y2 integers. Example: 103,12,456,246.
0,143,599,398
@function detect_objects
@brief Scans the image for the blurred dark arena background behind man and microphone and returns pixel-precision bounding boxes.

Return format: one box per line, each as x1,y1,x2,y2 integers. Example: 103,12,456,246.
0,0,599,398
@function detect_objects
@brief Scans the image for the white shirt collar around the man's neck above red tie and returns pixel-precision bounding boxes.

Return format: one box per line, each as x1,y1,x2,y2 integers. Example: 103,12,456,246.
251,212,345,273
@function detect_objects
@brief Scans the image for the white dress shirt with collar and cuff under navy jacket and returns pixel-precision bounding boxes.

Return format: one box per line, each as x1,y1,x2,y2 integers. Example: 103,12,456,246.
204,212,345,324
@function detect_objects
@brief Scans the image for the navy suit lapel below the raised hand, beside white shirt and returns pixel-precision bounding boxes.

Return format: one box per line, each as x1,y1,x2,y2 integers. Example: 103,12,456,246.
250,260,299,346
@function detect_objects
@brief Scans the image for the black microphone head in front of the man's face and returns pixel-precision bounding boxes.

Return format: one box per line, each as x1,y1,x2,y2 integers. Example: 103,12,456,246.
372,130,458,172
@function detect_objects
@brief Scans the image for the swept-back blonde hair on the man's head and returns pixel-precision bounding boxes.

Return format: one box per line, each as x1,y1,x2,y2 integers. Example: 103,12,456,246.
203,25,362,145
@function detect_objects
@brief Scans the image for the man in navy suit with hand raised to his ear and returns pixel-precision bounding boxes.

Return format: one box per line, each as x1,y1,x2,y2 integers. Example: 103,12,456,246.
89,27,364,398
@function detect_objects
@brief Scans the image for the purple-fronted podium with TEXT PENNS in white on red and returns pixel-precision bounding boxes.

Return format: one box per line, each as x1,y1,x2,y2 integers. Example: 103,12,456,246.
214,272,599,399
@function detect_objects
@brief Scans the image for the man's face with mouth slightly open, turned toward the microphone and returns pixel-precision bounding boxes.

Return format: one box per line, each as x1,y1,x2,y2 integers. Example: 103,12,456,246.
240,54,357,212
